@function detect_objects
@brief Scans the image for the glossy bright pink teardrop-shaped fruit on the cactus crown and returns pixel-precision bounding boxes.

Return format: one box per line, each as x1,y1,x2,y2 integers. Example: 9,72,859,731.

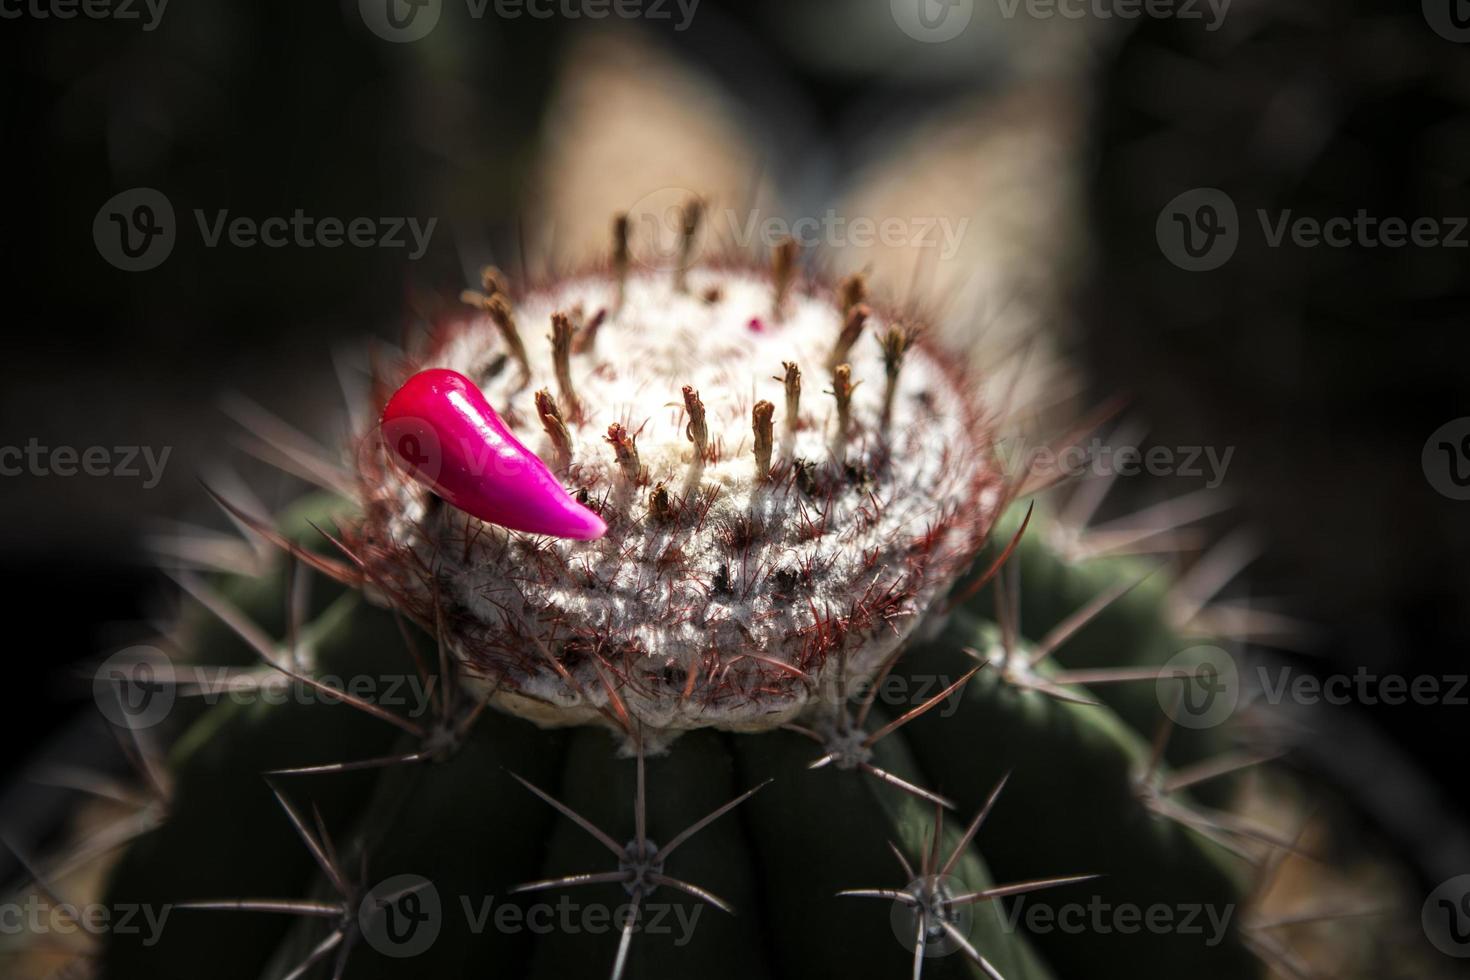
379,369,607,541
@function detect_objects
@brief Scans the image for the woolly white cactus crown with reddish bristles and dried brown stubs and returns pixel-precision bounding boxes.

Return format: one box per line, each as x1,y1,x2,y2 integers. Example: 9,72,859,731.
351,220,1001,746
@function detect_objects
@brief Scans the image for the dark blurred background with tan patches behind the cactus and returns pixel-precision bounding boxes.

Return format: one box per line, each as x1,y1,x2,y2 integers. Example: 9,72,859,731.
0,0,1470,952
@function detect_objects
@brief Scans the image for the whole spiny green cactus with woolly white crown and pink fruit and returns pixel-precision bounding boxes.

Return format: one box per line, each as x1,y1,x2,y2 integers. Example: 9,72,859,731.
77,209,1287,980
